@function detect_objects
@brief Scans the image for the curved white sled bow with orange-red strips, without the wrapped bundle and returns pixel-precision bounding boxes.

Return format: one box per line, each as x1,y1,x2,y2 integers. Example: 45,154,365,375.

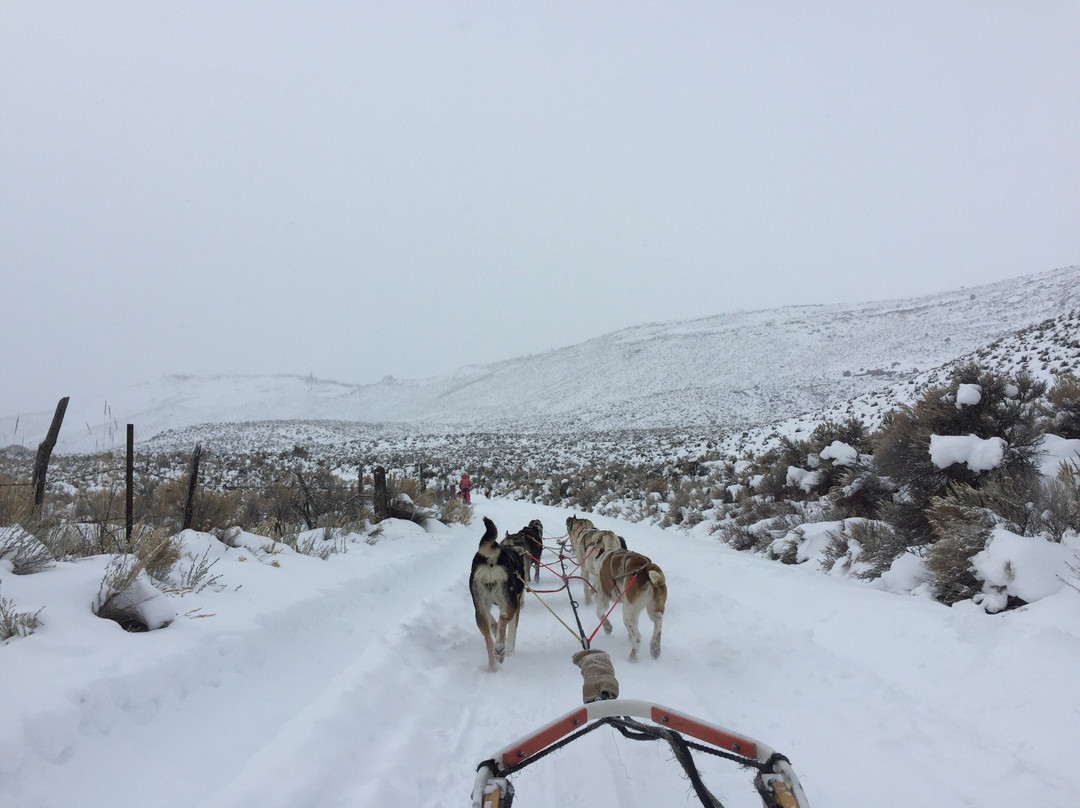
472,699,810,808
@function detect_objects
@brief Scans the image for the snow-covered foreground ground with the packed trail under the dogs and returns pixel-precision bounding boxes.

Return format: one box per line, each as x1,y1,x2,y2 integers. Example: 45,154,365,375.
0,500,1080,808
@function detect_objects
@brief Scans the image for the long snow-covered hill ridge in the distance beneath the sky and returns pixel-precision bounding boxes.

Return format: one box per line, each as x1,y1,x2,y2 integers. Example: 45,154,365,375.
0,267,1080,452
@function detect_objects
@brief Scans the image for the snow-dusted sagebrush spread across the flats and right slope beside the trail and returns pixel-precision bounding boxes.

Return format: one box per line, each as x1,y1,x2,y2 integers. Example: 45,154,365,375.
0,274,1080,610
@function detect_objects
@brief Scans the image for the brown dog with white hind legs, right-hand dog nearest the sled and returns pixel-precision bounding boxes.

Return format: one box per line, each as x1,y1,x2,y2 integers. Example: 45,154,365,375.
596,550,667,662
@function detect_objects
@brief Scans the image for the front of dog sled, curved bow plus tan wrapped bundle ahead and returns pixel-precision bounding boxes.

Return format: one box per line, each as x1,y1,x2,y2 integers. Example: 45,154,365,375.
472,649,809,808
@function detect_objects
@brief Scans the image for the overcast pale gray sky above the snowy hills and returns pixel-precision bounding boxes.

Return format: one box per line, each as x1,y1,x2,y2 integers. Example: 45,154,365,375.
0,0,1080,415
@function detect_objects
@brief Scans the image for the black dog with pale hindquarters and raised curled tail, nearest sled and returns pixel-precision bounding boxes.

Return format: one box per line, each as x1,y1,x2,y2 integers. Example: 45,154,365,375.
469,516,525,671
